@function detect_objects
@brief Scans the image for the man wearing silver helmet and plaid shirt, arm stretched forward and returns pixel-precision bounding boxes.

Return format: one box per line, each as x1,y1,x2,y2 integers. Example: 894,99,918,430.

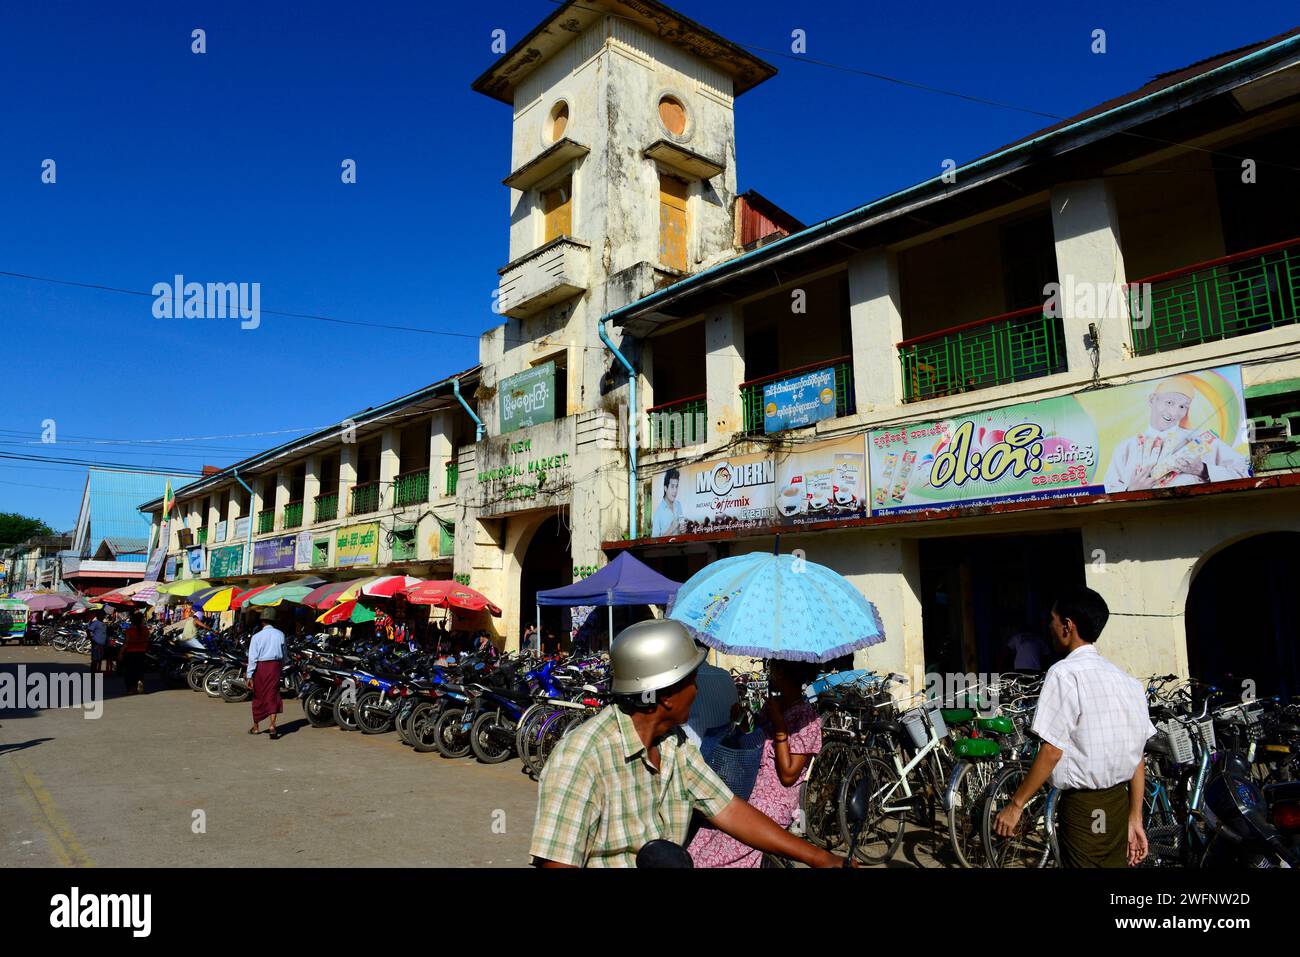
529,620,844,867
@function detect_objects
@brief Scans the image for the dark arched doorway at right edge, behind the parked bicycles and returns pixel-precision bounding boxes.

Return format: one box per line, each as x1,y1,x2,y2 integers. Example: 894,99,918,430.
1186,532,1300,697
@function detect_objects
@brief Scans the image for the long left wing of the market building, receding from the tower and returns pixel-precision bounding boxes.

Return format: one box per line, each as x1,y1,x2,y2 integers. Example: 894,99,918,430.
140,369,478,595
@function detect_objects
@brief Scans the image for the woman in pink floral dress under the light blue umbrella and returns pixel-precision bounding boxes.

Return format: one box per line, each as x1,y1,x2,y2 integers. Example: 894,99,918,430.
686,661,822,867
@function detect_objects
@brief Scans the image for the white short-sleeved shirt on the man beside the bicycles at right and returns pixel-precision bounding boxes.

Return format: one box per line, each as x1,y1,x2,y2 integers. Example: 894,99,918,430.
1032,645,1156,791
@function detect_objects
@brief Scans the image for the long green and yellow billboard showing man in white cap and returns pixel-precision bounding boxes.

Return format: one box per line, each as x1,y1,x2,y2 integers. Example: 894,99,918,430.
867,365,1251,515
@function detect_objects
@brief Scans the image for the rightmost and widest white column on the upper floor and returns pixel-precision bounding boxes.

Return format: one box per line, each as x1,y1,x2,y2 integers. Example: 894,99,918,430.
1044,179,1131,376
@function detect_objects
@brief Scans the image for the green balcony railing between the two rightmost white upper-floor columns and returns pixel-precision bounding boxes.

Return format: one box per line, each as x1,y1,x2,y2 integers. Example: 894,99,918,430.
898,306,1066,402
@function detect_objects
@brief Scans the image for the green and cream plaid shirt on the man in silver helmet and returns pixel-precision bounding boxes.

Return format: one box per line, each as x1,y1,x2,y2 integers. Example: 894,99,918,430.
529,705,732,867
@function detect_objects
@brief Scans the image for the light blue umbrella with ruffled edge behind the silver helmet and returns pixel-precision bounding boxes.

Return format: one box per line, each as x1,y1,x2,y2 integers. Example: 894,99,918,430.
668,553,885,663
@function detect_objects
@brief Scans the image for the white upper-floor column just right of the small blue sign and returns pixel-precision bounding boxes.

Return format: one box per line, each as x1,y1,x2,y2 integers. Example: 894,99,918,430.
849,250,904,412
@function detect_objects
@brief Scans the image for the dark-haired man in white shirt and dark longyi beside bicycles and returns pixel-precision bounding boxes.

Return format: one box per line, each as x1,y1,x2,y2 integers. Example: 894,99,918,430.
995,588,1156,867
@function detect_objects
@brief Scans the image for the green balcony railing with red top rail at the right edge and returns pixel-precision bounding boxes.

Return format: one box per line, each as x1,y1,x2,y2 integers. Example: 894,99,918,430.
1128,239,1300,355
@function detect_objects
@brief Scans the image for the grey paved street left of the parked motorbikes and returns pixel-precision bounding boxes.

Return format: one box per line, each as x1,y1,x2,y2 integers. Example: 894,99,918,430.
0,646,537,867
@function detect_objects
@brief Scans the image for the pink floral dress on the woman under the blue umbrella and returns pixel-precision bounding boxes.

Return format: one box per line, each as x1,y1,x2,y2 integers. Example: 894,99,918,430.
686,702,822,867
